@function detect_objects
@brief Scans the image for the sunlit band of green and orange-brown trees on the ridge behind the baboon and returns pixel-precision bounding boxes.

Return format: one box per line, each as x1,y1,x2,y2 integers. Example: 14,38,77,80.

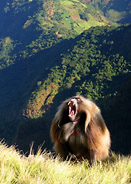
25,25,131,118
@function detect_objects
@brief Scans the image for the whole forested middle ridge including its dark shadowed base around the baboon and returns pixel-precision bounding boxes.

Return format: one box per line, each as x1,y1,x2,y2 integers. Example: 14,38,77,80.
15,25,131,154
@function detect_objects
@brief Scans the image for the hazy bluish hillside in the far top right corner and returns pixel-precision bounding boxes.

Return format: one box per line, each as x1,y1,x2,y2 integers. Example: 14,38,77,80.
82,0,131,23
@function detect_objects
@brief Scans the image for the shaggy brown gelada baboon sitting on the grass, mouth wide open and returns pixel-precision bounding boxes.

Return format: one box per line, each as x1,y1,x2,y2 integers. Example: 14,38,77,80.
50,96,111,163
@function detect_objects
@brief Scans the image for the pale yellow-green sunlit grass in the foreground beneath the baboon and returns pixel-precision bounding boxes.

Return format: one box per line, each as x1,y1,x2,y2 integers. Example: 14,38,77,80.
0,143,131,184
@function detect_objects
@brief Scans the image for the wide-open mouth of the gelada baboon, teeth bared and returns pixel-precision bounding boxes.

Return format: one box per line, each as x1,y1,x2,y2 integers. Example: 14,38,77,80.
68,99,78,120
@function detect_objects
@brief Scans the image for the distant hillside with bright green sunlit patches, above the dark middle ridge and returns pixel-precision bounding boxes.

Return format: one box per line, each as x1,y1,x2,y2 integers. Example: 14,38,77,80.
0,0,131,69
